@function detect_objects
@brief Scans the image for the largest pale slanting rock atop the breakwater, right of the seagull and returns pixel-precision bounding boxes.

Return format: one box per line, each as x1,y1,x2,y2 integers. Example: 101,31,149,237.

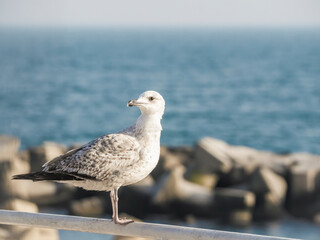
195,137,300,183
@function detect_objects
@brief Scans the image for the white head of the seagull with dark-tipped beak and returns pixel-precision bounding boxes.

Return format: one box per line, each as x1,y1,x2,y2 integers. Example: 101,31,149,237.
127,91,165,118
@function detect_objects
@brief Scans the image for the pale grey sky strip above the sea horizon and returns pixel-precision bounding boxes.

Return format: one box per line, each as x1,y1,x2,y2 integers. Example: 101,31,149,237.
0,0,320,27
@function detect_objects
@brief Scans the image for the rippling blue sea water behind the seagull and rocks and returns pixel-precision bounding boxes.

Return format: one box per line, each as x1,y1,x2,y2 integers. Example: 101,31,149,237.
0,28,320,239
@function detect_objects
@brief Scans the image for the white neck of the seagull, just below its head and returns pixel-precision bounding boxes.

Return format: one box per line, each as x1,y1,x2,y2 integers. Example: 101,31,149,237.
136,114,162,132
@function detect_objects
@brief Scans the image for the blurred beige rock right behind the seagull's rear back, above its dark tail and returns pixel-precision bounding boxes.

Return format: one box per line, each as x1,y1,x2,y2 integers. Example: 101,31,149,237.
29,142,67,172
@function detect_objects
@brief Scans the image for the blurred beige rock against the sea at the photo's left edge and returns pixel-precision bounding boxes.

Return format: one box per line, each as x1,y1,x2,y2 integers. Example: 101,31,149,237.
0,135,20,162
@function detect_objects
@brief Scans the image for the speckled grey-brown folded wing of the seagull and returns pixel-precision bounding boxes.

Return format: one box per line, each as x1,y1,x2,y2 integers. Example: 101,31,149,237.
43,133,140,180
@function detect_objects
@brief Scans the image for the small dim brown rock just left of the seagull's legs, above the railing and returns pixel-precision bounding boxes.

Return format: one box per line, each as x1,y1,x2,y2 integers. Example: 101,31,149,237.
69,196,107,217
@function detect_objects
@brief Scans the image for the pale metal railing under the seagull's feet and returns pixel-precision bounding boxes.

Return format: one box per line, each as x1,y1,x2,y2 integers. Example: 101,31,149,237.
0,210,298,240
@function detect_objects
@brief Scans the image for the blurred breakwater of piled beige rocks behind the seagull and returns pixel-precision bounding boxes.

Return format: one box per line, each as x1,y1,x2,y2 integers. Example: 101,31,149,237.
0,136,320,239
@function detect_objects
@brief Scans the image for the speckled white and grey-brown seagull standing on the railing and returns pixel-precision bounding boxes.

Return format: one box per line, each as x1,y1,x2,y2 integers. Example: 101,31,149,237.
13,91,165,225
